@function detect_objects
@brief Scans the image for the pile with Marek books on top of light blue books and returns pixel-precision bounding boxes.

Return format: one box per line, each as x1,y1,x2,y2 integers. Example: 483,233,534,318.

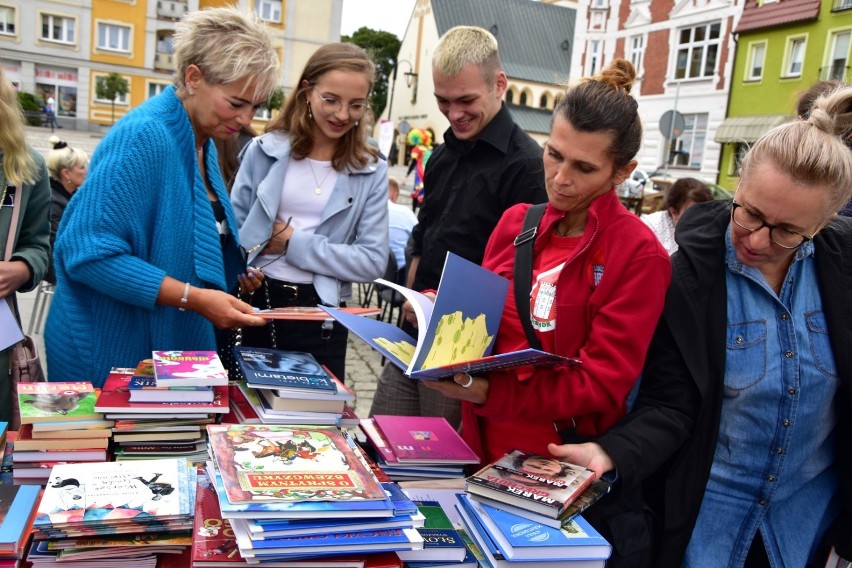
456,450,612,568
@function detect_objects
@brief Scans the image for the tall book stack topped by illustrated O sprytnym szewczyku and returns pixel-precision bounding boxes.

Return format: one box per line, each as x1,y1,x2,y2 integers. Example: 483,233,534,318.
207,424,423,565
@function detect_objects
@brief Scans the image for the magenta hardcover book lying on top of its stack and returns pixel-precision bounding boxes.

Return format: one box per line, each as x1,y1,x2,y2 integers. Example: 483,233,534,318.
373,415,479,465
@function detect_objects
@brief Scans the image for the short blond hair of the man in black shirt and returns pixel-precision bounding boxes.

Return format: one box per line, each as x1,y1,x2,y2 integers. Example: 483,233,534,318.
432,26,502,89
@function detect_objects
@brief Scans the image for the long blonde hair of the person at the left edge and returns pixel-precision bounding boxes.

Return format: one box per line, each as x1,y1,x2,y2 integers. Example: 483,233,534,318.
0,69,38,185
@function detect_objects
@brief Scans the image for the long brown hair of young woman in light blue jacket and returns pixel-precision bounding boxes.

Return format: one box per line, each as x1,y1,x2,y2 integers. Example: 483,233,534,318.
265,43,379,171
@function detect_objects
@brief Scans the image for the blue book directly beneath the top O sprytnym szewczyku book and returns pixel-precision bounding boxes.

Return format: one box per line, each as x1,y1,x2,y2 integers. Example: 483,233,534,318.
207,462,394,521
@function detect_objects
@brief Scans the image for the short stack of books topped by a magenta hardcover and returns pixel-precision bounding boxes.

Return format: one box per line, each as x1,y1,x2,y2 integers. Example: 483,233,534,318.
360,415,479,481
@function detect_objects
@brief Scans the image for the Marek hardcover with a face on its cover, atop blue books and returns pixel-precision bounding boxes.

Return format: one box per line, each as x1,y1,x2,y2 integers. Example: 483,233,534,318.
467,450,595,519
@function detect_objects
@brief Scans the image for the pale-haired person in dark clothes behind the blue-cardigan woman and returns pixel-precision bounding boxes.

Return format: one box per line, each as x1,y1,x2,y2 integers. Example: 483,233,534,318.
44,136,89,284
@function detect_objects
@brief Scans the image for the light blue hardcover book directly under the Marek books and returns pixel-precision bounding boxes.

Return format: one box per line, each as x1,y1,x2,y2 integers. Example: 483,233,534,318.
459,495,612,561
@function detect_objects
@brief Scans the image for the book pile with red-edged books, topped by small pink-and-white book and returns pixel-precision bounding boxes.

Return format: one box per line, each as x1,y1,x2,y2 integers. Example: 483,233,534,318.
95,351,229,463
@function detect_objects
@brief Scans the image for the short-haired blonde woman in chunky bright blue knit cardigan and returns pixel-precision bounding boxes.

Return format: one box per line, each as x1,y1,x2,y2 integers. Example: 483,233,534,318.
45,8,278,386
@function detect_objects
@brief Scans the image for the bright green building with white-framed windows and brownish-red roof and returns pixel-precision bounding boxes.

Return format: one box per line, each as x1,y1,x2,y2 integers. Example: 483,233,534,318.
715,0,852,190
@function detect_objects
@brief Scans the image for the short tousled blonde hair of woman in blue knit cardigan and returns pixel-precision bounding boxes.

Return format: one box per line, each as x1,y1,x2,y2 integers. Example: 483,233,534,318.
174,7,278,98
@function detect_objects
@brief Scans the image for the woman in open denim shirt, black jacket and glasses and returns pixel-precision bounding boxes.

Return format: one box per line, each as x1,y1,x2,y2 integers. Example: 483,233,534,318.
550,86,852,567
